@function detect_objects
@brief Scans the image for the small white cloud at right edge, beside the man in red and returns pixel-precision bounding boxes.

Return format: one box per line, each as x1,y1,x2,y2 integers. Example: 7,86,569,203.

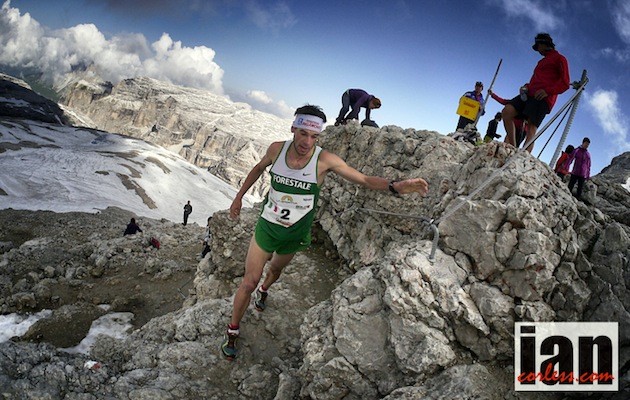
587,89,630,151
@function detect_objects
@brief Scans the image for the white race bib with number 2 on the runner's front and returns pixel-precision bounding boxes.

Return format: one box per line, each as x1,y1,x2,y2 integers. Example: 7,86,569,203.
262,188,315,227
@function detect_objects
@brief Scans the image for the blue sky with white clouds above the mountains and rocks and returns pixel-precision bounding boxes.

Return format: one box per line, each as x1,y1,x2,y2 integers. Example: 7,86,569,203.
0,0,630,174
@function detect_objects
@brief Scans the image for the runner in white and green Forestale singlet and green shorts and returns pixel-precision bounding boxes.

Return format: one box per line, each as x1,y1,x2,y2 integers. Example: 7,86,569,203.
221,105,429,359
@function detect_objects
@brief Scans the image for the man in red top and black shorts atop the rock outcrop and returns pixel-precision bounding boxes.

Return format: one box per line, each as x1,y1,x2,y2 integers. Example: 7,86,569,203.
503,33,571,153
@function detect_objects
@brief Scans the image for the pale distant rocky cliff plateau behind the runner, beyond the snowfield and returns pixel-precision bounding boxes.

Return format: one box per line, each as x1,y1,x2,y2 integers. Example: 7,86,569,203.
59,75,291,196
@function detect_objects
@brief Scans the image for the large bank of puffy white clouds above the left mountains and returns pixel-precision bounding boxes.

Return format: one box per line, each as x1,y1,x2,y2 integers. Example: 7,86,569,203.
0,1,223,94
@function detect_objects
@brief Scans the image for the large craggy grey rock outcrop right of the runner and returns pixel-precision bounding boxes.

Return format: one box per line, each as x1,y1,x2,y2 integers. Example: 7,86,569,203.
301,127,630,398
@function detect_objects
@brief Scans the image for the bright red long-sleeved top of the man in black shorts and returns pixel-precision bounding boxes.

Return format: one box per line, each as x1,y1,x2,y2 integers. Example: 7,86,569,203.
527,49,571,111
